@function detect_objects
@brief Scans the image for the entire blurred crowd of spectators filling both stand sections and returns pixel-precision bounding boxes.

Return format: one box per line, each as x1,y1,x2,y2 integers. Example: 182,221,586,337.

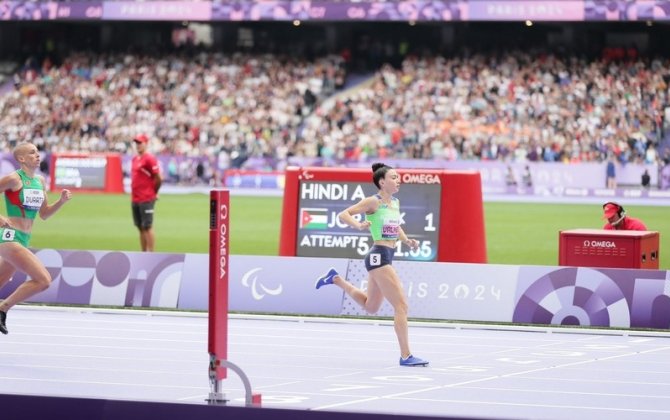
0,47,670,167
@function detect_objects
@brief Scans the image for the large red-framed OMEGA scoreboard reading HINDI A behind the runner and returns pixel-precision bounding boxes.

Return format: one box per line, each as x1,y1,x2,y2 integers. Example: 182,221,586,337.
279,168,486,262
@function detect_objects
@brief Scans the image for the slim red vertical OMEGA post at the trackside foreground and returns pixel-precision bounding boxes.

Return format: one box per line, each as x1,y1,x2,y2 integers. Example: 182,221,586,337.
208,191,230,382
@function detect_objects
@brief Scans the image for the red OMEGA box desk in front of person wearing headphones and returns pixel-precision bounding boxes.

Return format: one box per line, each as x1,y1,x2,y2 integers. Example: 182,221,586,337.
558,229,659,269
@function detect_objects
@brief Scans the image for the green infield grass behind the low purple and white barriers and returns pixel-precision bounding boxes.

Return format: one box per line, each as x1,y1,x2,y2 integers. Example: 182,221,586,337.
31,194,670,270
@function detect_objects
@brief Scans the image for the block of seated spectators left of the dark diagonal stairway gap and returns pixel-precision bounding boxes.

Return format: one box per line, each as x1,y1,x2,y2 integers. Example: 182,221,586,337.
0,53,345,166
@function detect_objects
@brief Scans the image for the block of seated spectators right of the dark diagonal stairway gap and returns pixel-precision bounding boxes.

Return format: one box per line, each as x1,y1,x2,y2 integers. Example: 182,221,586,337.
303,51,670,163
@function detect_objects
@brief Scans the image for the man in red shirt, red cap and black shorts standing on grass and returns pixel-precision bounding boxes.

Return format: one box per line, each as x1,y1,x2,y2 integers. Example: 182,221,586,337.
130,134,163,252
